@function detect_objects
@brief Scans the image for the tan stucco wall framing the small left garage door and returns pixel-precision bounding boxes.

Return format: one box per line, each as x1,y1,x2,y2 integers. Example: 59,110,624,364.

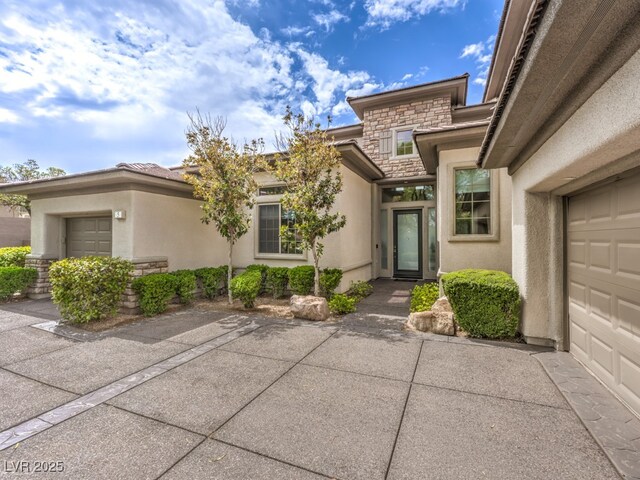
31,191,133,258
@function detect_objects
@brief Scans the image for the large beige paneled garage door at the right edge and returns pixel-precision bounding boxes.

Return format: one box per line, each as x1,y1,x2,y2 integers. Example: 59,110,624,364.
567,175,640,413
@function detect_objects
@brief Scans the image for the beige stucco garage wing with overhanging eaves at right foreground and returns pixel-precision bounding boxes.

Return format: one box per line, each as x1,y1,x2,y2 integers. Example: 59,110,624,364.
478,0,640,413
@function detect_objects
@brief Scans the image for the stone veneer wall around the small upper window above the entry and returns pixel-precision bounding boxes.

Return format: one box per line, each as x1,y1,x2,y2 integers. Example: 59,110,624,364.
363,96,452,178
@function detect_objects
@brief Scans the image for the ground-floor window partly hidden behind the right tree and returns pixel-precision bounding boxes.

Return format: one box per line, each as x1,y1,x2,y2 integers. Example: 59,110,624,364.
258,203,302,255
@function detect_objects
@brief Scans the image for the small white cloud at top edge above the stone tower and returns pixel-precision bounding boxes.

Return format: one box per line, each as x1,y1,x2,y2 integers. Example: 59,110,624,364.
364,0,466,29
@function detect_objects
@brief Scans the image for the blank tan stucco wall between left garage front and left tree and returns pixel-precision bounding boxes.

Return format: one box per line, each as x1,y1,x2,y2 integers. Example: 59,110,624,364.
129,191,227,270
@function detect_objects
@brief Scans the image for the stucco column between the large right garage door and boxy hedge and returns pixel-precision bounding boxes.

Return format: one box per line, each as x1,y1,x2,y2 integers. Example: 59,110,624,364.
512,185,564,349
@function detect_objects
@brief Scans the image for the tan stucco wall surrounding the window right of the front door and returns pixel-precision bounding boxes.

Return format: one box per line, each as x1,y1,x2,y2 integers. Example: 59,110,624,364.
437,147,511,273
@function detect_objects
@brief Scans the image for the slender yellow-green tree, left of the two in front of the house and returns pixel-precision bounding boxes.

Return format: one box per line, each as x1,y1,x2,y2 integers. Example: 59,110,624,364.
183,111,263,303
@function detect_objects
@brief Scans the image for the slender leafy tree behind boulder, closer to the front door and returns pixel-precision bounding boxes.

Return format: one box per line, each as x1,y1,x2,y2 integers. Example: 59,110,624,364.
269,107,346,296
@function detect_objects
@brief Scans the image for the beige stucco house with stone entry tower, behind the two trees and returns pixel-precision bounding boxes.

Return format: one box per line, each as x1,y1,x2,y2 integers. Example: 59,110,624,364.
3,75,511,295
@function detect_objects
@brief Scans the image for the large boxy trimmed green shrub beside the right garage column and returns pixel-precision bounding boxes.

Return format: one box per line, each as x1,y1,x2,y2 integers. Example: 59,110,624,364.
442,270,520,338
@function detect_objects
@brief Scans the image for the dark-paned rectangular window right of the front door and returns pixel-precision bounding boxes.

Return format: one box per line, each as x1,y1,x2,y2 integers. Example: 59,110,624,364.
455,168,491,235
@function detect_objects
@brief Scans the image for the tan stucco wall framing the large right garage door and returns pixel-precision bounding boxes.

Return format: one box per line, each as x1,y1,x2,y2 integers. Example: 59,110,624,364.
512,48,640,348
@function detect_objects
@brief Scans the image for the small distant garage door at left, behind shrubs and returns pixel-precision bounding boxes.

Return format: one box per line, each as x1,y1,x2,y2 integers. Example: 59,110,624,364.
67,217,111,257
